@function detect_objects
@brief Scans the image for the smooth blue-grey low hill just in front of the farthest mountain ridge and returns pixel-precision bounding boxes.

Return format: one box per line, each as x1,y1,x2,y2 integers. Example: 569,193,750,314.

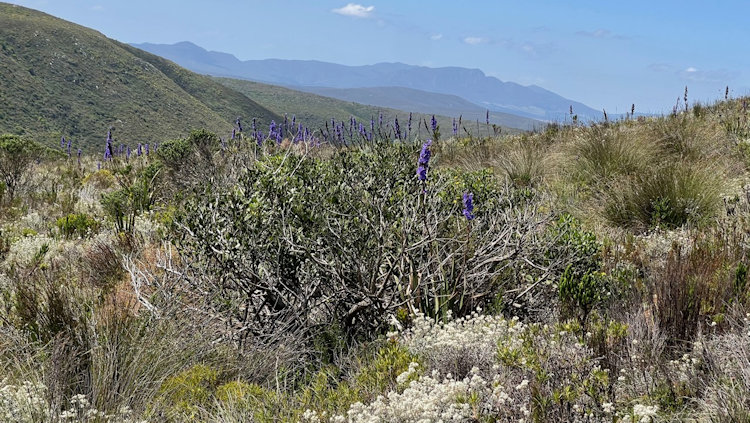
299,87,546,130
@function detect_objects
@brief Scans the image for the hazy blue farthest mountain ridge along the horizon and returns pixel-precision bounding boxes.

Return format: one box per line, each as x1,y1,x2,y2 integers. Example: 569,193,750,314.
134,41,601,121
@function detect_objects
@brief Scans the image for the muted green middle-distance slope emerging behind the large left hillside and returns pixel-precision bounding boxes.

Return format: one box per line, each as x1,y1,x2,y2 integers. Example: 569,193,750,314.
214,78,524,136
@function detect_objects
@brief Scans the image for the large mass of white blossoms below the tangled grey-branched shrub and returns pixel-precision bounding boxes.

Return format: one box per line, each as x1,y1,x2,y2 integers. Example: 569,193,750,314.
303,313,615,423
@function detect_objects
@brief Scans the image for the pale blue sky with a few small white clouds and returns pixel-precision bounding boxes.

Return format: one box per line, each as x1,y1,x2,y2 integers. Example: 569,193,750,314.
5,0,750,113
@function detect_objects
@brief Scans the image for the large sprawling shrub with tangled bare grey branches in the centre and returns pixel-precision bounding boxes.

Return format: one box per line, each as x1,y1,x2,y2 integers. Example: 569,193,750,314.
176,145,545,352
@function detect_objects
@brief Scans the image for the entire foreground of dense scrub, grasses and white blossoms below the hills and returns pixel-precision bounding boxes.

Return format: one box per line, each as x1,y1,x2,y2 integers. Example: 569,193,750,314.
0,100,750,422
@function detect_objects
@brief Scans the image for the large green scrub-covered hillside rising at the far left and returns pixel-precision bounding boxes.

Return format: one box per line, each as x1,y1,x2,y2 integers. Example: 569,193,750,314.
0,3,277,149
